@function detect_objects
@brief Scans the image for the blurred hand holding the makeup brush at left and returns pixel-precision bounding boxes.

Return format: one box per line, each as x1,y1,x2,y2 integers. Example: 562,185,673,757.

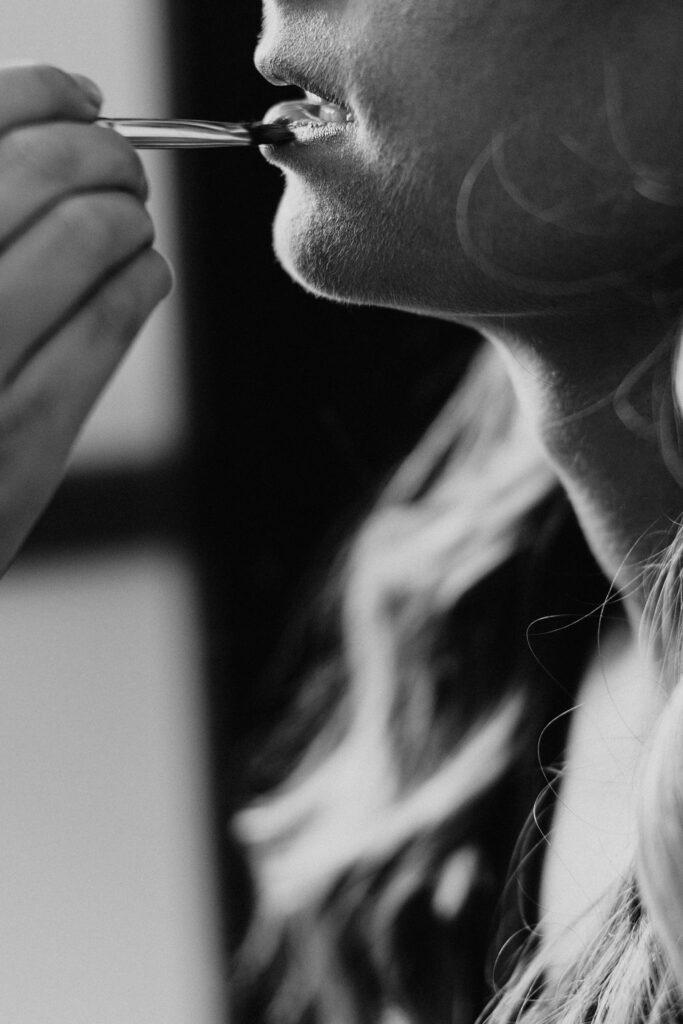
0,66,171,571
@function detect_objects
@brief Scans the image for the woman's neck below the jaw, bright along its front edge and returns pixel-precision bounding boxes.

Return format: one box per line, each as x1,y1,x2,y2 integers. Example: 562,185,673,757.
485,306,683,623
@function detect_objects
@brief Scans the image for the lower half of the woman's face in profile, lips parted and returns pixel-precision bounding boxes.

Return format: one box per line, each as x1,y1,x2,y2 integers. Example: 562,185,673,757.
257,0,683,319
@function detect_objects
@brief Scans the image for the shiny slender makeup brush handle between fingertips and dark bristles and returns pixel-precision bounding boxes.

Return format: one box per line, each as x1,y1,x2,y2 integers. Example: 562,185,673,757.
97,118,257,150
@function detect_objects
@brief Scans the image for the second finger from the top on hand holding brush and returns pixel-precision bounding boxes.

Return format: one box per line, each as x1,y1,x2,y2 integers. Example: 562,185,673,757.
0,122,148,247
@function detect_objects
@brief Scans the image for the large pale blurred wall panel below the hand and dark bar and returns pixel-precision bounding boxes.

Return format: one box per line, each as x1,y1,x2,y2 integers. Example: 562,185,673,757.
0,551,219,1024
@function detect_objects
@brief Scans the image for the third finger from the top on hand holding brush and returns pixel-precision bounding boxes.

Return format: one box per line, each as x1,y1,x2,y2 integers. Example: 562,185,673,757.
0,193,155,381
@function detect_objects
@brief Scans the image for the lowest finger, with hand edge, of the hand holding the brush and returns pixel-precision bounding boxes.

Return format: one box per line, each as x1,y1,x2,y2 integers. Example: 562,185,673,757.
0,250,172,569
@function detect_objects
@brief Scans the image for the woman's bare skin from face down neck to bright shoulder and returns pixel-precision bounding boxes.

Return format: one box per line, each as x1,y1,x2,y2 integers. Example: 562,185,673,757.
257,0,683,972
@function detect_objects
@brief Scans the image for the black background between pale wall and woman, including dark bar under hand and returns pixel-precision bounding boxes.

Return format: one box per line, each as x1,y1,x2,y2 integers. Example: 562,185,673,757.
28,0,481,1007
